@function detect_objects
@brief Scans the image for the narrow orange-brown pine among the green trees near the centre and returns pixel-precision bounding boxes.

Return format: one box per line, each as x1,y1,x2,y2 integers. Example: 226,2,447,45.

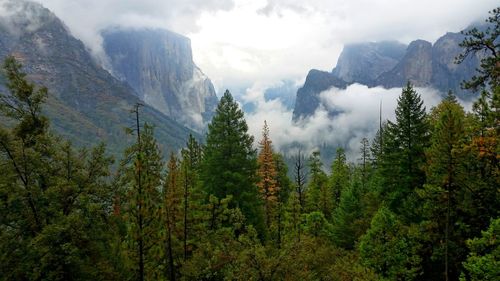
257,121,279,229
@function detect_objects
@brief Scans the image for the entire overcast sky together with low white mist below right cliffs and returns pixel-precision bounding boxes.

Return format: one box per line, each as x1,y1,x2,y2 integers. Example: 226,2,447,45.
30,0,498,160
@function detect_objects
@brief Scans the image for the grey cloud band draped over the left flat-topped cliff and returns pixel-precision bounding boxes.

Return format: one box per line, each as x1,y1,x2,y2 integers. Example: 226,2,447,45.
34,0,233,59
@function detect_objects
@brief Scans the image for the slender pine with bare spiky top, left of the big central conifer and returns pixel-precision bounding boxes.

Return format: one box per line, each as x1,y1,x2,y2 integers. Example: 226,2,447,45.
118,117,163,280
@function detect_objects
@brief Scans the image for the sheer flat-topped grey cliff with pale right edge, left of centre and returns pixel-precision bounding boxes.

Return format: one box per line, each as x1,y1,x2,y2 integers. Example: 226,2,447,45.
102,29,218,129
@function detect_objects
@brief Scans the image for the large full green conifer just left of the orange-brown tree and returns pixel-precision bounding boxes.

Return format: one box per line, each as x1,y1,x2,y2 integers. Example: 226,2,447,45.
200,91,264,234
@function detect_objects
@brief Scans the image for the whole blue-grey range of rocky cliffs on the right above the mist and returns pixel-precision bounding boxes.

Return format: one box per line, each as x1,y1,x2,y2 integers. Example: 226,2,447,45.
293,32,480,120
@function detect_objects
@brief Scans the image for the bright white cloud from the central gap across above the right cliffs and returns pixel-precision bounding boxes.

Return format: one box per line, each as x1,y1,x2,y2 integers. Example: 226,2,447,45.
188,0,498,95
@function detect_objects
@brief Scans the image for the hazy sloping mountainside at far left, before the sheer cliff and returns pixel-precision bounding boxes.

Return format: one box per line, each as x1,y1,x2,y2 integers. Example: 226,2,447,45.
0,0,196,156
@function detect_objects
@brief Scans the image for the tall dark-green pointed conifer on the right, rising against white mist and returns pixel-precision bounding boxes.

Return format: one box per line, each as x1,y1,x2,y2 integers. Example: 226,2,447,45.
380,83,429,219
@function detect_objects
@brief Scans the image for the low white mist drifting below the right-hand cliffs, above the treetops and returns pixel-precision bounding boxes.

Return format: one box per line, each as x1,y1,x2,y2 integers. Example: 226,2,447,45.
246,84,468,161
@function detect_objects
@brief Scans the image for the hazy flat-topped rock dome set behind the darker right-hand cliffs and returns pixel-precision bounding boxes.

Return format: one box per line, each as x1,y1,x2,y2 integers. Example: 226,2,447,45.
332,41,407,85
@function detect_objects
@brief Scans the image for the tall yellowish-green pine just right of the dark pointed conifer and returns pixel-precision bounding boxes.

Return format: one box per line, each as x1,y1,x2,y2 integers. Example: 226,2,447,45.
419,92,466,280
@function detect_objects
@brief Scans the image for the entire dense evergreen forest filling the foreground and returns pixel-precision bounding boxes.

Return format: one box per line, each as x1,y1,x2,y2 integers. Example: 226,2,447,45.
0,6,500,280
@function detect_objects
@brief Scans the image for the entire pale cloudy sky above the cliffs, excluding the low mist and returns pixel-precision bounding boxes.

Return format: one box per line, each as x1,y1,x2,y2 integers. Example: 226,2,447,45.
38,0,498,92
